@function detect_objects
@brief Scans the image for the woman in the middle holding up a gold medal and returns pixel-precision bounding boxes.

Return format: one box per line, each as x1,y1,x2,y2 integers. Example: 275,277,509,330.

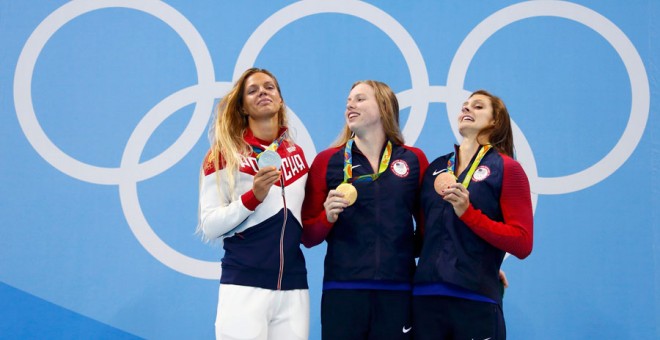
303,80,428,339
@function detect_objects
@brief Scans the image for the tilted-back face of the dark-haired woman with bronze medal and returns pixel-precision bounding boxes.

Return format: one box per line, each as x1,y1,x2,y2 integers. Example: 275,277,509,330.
458,94,495,137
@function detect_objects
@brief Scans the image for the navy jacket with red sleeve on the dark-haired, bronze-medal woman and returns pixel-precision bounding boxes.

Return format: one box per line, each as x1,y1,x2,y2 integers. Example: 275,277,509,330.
415,149,533,303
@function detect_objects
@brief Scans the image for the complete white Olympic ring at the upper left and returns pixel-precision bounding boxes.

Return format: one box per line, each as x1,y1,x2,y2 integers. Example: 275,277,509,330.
14,0,215,184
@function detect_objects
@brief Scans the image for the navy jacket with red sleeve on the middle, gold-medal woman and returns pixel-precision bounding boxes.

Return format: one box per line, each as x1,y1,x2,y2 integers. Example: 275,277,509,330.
302,144,428,289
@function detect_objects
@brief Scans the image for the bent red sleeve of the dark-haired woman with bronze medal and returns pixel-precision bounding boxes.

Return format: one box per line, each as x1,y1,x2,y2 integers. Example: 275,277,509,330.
461,156,534,259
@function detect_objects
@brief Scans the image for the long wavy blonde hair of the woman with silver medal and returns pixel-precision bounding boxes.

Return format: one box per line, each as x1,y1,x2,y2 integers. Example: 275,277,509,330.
210,68,287,197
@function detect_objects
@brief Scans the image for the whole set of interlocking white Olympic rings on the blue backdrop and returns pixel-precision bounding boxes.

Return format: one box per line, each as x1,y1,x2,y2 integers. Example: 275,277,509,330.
14,0,650,279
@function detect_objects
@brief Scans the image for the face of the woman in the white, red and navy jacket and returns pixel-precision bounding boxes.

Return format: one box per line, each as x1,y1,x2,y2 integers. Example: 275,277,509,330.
243,72,283,121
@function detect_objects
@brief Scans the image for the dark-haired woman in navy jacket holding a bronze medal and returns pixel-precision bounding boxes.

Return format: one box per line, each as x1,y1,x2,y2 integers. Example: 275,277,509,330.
413,90,533,340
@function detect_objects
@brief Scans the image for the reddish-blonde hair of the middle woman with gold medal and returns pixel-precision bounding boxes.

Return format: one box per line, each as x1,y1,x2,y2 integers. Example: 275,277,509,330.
333,80,404,147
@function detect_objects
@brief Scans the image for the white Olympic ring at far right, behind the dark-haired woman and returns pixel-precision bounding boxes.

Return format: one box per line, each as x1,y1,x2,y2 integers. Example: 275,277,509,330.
447,1,651,194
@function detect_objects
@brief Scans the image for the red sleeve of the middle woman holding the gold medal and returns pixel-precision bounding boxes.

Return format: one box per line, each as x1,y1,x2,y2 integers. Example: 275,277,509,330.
302,149,334,248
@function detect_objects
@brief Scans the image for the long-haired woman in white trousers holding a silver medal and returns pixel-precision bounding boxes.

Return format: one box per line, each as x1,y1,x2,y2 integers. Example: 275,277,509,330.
198,68,309,340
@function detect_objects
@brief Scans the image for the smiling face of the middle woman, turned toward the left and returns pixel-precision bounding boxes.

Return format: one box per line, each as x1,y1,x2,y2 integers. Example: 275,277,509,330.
344,83,383,135
